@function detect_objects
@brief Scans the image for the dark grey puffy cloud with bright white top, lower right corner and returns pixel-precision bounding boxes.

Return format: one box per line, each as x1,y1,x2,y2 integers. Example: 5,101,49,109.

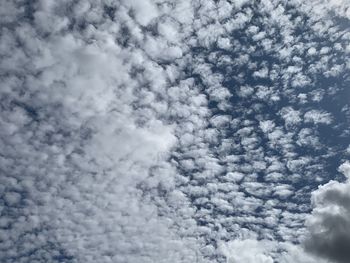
305,162,350,263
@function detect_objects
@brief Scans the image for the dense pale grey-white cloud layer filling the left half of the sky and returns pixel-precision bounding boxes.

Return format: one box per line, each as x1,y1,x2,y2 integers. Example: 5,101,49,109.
0,1,205,263
